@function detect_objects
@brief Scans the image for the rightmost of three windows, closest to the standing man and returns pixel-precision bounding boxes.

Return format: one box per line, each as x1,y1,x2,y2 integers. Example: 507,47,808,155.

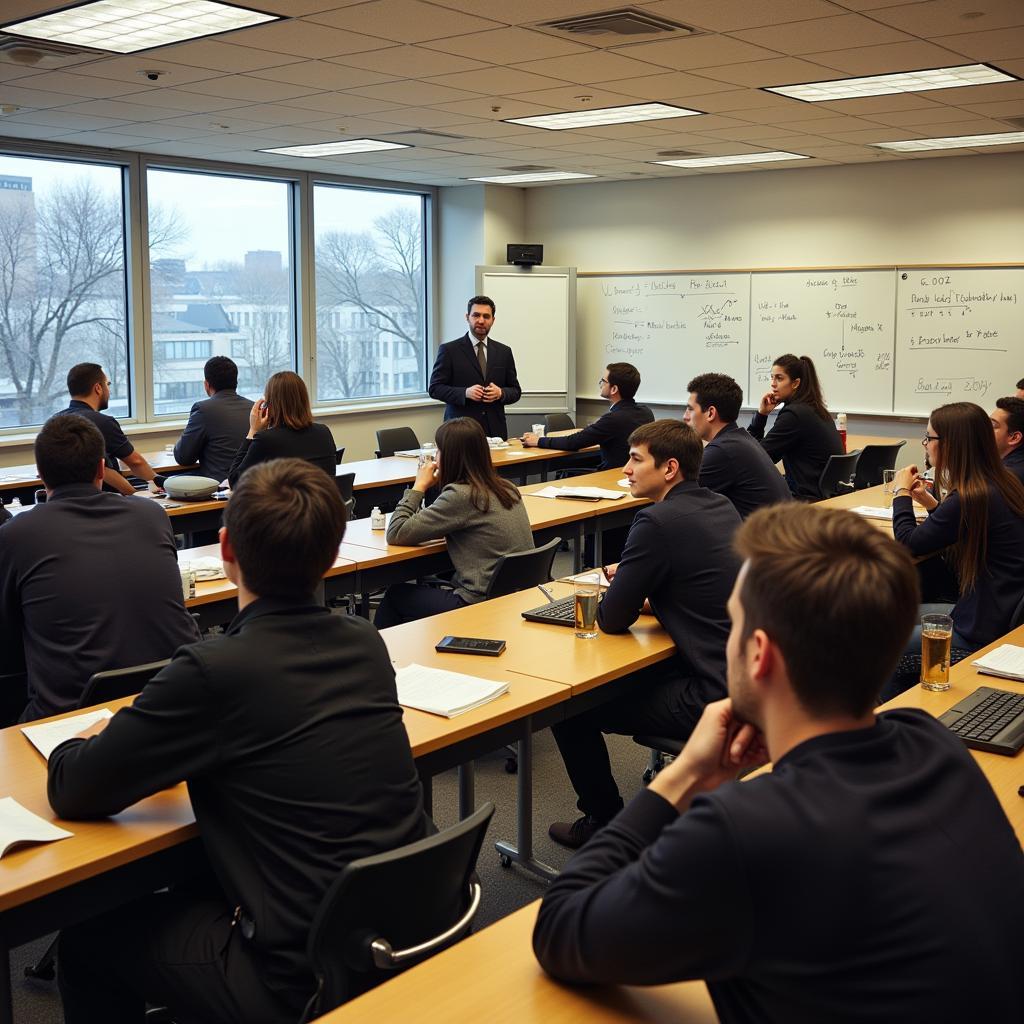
313,182,427,402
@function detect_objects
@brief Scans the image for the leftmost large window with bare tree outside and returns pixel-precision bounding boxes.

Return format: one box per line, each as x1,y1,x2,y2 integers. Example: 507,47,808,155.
0,155,132,427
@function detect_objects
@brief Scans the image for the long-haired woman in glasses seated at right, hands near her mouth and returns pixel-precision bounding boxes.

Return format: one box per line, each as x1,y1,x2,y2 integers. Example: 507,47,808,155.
888,401,1024,659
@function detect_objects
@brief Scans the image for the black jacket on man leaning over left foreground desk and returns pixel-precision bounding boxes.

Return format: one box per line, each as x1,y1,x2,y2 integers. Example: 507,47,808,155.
48,598,425,1018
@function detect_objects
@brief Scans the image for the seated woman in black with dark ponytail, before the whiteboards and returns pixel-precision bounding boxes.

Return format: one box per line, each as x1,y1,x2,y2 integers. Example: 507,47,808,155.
749,354,843,502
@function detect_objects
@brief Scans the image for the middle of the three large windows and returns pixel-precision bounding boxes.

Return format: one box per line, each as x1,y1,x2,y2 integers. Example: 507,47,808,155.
146,169,296,415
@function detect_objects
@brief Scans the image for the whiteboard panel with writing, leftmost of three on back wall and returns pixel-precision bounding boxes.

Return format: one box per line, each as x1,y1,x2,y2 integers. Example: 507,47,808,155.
577,273,751,404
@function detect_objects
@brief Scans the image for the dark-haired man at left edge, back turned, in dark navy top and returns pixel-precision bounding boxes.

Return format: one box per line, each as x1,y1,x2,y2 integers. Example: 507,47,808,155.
0,415,199,721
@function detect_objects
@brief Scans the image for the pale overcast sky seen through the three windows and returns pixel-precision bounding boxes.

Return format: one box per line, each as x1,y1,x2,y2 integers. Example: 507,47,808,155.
0,150,420,269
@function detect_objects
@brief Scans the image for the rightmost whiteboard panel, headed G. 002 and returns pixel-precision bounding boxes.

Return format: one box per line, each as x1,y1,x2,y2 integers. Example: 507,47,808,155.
895,267,1024,416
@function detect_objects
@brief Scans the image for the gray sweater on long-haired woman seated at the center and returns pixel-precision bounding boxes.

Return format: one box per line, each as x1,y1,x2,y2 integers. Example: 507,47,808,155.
387,483,534,604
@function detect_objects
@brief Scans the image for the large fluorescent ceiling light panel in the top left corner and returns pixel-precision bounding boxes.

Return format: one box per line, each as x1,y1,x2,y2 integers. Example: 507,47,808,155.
2,0,281,53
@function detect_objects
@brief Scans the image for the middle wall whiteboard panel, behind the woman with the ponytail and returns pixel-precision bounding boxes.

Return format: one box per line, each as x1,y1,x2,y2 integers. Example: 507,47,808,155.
750,269,896,413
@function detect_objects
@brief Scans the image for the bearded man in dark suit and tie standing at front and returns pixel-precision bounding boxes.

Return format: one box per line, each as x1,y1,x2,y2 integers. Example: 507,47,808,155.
427,295,522,437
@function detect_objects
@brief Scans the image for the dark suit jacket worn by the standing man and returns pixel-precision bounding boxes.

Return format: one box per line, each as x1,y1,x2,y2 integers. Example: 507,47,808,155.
427,334,522,437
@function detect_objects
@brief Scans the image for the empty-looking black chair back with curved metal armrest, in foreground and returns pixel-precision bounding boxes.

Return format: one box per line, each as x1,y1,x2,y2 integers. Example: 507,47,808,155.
303,803,495,1021
